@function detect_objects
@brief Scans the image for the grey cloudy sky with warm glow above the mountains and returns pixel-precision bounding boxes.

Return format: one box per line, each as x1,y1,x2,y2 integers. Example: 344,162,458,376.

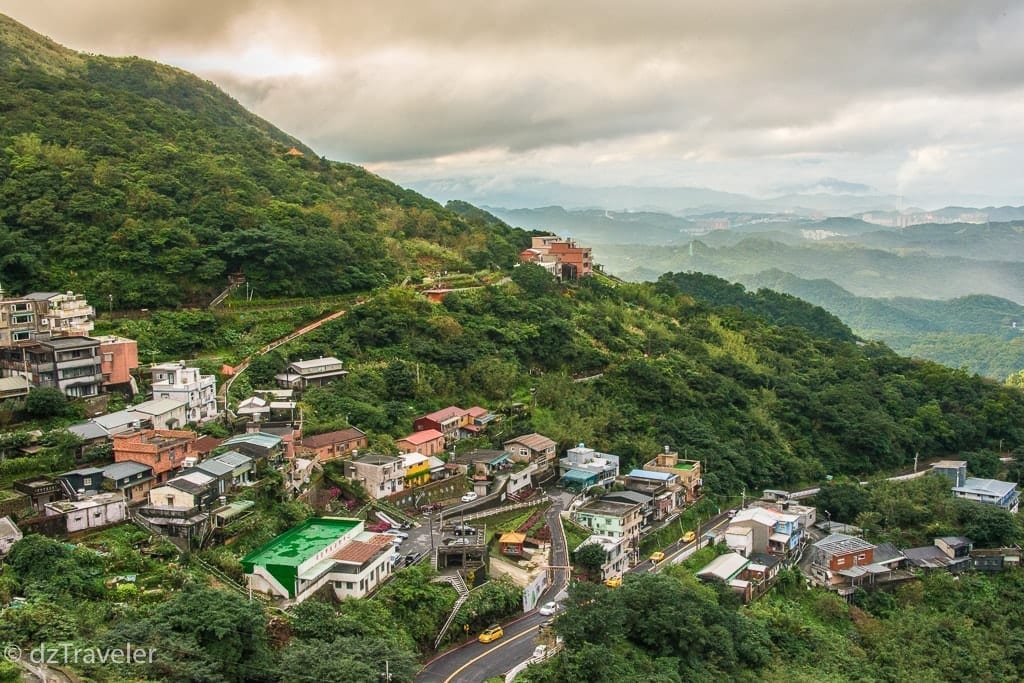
0,0,1024,206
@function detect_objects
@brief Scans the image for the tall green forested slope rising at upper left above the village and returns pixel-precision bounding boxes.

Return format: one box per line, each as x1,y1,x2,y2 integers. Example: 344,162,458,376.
0,17,526,308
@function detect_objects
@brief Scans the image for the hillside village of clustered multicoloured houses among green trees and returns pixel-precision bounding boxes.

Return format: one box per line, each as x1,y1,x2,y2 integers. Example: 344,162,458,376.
0,282,1020,626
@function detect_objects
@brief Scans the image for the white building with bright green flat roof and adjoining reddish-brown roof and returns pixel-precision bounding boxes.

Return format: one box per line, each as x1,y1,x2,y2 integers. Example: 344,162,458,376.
242,517,394,604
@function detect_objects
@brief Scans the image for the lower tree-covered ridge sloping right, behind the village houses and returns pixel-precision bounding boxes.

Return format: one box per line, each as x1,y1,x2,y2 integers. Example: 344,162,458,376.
247,264,1024,493
